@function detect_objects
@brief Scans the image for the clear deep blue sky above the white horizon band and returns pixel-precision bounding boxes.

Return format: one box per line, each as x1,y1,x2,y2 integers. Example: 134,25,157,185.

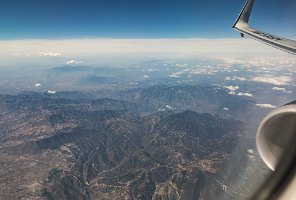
0,0,296,40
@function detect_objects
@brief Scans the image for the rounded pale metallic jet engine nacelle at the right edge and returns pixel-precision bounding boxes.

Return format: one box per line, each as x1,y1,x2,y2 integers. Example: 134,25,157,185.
256,101,296,170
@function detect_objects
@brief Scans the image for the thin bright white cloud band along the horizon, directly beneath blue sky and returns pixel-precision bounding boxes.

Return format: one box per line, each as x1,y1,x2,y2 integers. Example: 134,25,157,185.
0,38,272,56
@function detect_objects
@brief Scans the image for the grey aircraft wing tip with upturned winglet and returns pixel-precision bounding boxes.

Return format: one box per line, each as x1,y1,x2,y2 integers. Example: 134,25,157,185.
232,0,296,55
